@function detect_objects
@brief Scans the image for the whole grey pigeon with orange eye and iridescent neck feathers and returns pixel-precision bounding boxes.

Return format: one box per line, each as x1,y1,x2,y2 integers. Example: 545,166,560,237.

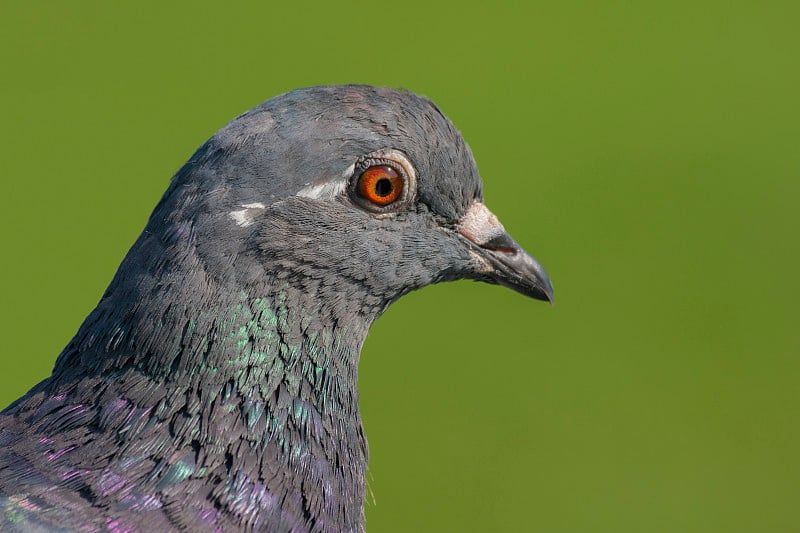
0,85,553,532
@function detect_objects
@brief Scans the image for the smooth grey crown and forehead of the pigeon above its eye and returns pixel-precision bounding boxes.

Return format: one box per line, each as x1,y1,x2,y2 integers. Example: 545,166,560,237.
190,86,488,219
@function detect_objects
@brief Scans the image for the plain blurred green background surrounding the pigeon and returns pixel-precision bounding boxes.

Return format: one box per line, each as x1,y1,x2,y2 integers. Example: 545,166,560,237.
0,0,800,533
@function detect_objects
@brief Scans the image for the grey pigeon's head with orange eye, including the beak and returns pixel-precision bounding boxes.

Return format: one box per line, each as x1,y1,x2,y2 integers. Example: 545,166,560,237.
151,85,553,318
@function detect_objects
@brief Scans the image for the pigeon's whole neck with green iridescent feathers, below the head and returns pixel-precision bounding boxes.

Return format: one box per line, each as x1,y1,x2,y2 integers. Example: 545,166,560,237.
54,280,370,531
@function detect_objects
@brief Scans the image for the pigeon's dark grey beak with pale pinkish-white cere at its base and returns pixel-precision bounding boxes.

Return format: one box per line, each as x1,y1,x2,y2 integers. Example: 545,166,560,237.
458,202,553,305
